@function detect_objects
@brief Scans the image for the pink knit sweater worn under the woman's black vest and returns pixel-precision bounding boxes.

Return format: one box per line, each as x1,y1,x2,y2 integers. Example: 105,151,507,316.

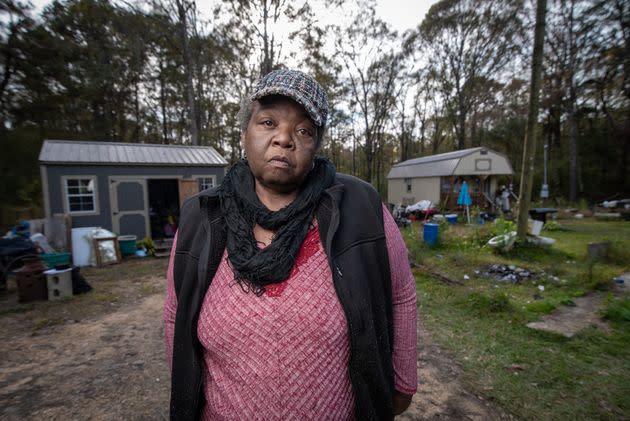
164,206,417,420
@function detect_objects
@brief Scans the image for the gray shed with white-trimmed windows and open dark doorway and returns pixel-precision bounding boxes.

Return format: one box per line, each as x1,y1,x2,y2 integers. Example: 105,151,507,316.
39,140,227,239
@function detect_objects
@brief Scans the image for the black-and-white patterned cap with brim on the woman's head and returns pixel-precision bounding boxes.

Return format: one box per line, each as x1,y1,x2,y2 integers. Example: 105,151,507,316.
250,69,328,127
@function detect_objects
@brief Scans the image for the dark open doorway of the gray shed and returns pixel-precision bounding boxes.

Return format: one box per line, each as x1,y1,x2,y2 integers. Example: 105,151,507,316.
147,179,179,240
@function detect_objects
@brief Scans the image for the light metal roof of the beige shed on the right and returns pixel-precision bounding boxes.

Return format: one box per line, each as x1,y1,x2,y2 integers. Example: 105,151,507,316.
387,147,507,179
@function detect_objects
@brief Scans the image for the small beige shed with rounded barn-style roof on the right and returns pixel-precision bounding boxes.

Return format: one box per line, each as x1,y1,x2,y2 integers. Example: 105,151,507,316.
387,147,514,209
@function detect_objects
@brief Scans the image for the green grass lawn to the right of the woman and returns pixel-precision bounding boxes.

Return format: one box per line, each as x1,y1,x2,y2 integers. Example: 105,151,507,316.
403,219,630,420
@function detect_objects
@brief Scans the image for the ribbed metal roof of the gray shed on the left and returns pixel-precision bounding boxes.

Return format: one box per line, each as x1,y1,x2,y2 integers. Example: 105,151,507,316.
39,140,227,166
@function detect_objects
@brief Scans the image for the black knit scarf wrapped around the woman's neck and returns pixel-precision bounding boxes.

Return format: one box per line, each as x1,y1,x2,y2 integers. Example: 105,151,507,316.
219,158,335,295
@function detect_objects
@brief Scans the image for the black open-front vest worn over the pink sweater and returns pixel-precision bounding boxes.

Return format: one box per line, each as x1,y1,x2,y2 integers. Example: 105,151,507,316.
171,174,394,420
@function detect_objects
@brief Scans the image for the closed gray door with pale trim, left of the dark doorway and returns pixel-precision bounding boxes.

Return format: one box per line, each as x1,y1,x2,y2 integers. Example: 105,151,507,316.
109,177,149,240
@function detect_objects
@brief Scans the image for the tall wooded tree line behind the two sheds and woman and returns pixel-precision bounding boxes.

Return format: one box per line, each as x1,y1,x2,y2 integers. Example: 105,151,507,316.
0,0,630,223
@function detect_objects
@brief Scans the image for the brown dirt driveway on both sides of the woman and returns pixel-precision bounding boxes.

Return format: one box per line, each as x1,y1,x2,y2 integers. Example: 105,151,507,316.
0,260,509,420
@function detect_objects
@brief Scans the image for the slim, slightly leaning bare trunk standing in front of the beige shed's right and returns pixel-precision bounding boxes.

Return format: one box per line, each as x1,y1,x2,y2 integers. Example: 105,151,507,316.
517,0,547,240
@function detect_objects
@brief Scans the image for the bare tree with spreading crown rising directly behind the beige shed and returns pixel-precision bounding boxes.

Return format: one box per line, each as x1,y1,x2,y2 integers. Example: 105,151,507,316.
418,0,523,149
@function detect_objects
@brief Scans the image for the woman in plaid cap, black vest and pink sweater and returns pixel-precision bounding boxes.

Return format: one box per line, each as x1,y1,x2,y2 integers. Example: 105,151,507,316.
164,70,417,420
